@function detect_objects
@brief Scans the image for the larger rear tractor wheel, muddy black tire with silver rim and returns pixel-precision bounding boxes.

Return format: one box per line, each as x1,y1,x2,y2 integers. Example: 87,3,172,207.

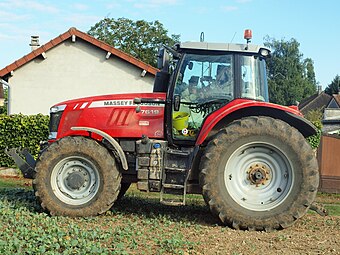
200,117,319,231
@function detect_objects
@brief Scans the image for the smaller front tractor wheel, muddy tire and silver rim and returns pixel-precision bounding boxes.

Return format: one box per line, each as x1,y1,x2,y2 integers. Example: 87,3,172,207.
33,136,121,217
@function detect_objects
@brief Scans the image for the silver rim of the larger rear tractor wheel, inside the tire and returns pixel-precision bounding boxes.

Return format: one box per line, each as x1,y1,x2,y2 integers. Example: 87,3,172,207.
224,142,294,211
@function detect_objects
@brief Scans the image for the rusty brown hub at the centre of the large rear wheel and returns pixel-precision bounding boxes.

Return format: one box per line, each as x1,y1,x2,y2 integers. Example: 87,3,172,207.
247,163,271,186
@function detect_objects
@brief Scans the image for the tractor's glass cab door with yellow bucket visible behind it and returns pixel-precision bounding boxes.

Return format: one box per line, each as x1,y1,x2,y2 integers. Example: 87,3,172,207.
171,54,234,142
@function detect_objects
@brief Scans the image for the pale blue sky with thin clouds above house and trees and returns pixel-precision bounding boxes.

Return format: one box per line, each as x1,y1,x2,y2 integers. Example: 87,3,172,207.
0,0,340,88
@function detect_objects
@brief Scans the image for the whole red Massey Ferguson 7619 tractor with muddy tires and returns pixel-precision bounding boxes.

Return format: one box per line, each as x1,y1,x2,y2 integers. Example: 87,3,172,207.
9,31,319,231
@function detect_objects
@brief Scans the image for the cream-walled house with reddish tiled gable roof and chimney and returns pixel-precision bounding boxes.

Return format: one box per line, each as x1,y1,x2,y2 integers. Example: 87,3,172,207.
0,28,157,115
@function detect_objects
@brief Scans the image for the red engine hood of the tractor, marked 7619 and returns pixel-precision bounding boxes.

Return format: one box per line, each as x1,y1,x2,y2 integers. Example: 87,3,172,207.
55,93,166,139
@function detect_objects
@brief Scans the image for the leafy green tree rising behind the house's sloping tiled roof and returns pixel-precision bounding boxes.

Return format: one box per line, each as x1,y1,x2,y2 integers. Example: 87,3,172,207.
88,18,180,66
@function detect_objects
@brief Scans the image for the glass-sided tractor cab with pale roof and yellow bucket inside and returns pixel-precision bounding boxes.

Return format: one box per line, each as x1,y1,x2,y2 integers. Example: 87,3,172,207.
154,31,270,142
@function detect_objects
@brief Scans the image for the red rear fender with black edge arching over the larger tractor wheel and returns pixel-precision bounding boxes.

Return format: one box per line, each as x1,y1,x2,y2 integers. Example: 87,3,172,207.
196,101,317,145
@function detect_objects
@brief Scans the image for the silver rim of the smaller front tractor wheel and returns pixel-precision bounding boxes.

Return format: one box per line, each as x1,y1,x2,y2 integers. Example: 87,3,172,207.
51,156,100,205
